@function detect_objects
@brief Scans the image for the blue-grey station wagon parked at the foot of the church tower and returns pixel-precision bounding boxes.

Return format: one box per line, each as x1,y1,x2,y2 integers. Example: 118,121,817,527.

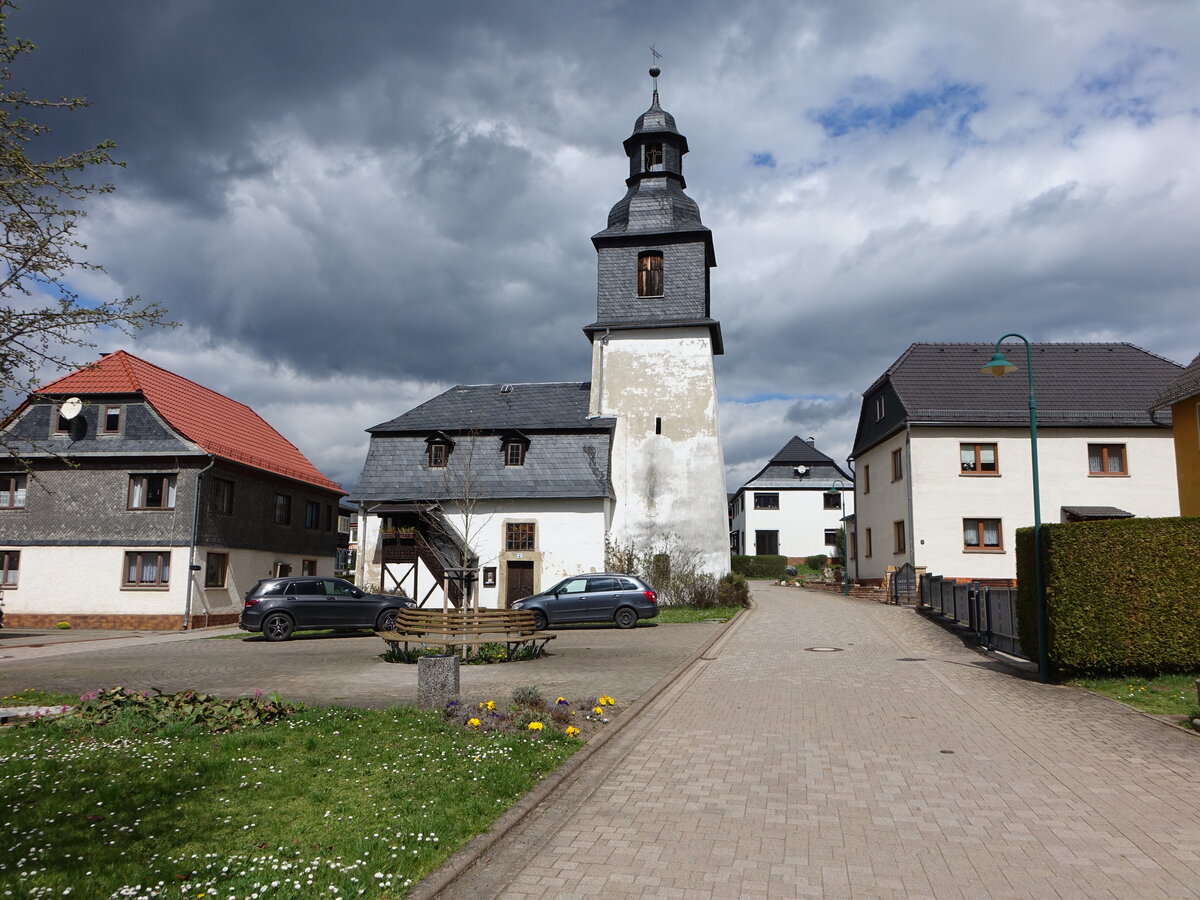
512,572,659,629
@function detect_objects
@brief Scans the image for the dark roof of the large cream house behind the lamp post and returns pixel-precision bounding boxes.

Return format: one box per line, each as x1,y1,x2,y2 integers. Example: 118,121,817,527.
854,342,1182,456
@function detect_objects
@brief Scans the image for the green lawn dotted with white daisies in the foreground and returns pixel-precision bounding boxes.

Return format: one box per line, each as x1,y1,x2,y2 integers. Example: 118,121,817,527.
0,691,582,900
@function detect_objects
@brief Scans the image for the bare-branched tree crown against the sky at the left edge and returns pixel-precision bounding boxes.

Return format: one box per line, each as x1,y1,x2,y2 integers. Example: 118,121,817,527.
0,0,169,449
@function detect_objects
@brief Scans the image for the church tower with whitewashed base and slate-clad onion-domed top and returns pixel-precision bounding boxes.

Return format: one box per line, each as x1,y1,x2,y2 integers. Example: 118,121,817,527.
583,67,730,575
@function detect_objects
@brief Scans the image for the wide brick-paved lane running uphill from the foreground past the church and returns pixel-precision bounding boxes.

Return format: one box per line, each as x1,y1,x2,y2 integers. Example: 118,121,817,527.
442,586,1200,900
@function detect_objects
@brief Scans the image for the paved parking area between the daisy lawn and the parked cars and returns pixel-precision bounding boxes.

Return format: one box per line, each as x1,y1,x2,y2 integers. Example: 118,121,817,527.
0,623,721,709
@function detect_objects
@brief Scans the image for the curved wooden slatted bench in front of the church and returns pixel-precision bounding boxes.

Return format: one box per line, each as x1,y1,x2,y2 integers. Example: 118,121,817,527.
376,610,558,660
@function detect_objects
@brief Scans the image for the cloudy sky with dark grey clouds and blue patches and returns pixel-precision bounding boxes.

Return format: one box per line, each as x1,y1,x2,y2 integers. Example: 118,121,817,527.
8,0,1200,490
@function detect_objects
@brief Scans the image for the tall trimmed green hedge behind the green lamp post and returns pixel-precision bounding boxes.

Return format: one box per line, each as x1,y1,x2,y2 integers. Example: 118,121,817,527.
1016,518,1200,676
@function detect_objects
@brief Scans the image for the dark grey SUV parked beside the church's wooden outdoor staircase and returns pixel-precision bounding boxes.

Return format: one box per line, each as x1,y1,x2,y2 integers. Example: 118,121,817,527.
238,575,416,641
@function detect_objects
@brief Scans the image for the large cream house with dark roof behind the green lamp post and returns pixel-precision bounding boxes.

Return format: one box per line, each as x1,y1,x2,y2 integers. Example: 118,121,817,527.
851,343,1181,582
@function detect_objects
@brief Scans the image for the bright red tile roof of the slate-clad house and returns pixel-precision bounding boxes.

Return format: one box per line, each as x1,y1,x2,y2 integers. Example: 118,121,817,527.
37,350,344,493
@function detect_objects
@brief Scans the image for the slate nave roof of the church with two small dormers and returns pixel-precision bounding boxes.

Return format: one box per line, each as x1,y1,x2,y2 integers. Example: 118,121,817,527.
350,382,614,503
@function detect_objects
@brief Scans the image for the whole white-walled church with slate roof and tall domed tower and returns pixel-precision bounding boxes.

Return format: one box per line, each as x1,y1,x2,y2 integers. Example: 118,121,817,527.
349,70,728,607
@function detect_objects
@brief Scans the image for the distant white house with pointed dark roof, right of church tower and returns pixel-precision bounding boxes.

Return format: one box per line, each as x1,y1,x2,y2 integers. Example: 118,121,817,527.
730,437,854,559
